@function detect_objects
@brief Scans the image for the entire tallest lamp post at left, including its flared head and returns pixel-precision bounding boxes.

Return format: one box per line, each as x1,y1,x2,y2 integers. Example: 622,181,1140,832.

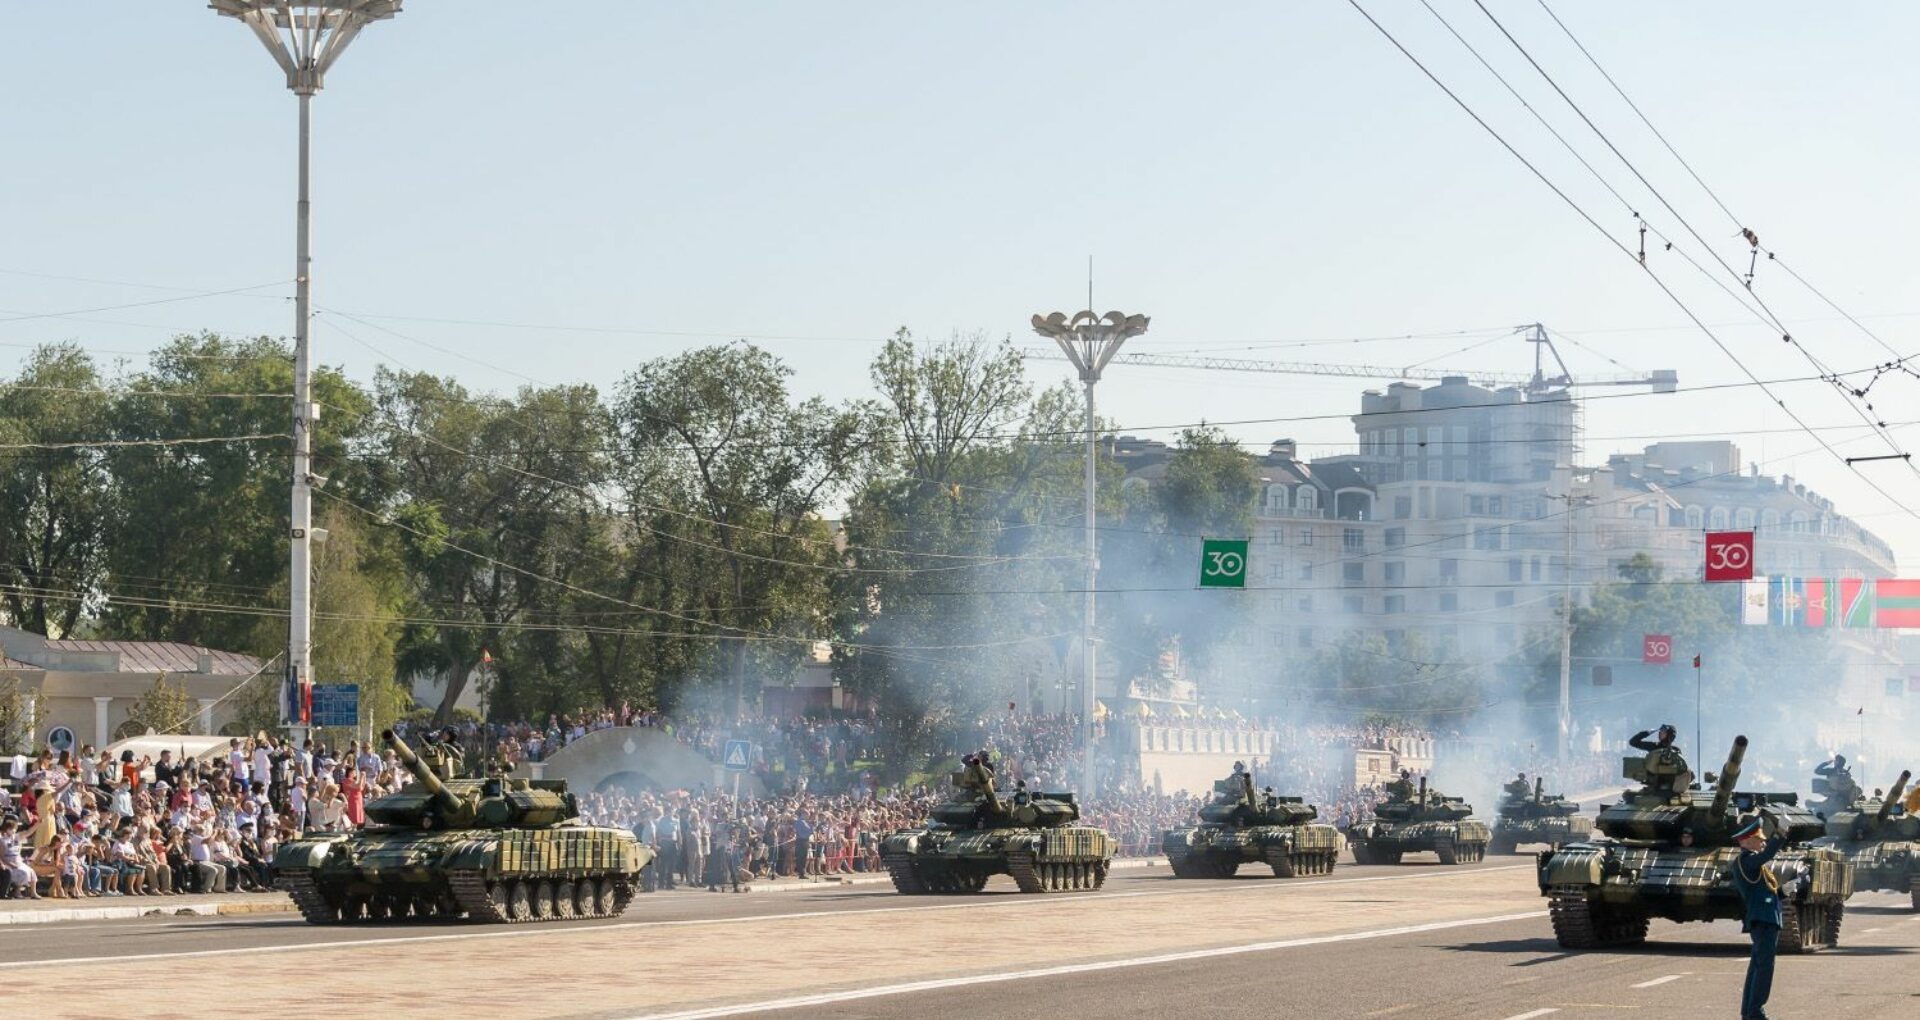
207,0,401,741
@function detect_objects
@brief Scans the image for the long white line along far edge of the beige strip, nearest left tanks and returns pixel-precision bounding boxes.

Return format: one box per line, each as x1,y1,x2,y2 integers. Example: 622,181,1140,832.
0,864,1534,970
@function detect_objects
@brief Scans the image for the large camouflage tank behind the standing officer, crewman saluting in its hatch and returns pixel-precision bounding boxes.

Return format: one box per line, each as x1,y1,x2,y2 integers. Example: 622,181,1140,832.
1538,738,1853,953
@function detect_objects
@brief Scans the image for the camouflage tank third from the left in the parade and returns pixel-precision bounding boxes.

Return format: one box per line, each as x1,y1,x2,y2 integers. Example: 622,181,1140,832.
1160,780,1340,878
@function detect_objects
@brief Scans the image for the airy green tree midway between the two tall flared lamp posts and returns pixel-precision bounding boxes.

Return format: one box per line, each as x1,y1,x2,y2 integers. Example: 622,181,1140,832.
612,344,879,709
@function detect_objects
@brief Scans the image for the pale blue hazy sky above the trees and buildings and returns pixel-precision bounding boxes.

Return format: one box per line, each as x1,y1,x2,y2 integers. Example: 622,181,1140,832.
0,0,1920,565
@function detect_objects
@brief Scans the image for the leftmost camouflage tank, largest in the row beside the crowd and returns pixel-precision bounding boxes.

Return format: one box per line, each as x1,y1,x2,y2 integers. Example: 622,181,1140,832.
273,730,653,924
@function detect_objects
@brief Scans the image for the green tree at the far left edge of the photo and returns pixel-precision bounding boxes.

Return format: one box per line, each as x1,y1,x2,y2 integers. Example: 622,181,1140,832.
0,344,115,638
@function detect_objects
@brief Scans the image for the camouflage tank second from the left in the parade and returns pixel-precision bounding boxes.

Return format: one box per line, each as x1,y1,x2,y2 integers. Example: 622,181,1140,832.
879,772,1114,895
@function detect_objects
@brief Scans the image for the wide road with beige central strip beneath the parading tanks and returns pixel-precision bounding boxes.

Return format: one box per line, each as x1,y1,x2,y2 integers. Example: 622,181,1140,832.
0,857,1920,1020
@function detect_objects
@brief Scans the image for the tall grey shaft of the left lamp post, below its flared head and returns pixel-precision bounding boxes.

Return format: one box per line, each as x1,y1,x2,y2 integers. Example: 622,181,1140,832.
286,88,315,741
